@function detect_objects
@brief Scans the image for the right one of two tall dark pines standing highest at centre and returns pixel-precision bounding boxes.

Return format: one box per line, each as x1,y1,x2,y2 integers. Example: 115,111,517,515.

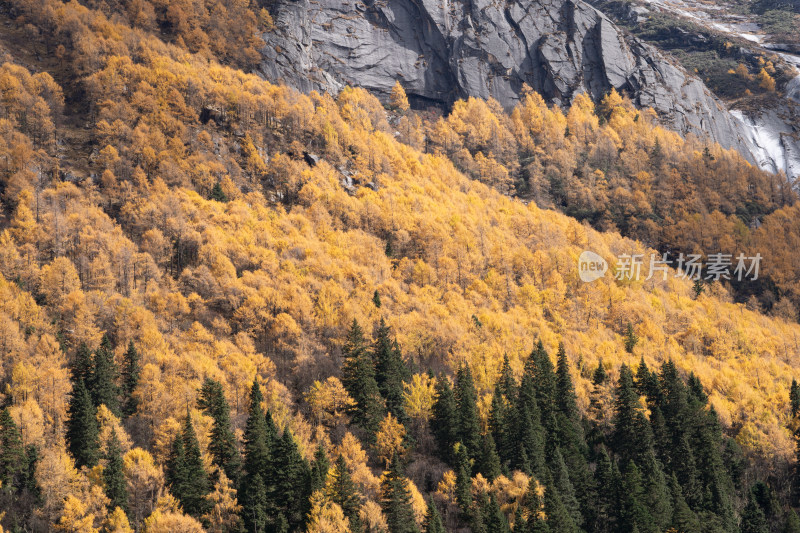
372,319,411,424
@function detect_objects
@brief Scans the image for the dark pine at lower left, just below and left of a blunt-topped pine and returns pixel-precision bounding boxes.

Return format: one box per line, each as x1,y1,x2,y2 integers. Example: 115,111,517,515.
166,413,211,516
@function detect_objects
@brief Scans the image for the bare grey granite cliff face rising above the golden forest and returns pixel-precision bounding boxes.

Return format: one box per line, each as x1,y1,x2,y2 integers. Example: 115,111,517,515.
261,0,754,161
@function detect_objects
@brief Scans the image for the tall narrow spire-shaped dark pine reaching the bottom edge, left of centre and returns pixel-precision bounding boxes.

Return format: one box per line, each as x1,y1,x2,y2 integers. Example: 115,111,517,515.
237,380,273,533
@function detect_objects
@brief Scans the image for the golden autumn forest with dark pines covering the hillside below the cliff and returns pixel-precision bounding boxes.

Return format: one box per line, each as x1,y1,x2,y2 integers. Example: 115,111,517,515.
0,0,800,533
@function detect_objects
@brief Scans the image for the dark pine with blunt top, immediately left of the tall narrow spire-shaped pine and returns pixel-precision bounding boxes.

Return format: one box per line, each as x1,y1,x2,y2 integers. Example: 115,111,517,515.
197,378,242,483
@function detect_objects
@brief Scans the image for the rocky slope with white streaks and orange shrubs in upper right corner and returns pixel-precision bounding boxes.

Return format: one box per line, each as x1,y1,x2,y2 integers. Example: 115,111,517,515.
592,0,800,179
